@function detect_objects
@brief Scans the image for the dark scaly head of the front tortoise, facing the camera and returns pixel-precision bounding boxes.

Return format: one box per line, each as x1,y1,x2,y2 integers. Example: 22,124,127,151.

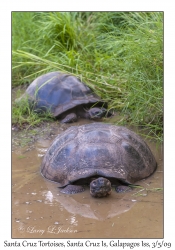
90,177,112,198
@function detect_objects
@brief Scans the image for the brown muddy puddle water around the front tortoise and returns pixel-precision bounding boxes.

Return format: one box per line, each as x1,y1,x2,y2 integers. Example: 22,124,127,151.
12,120,163,239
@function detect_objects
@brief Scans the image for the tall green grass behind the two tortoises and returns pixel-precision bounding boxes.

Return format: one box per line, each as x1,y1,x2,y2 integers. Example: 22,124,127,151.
12,12,163,141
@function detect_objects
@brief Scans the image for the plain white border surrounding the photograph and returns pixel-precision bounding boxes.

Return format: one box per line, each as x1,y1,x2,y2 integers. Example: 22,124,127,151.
0,0,175,249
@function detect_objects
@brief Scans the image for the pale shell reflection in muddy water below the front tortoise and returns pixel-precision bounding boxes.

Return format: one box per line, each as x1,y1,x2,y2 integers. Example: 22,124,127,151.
43,180,136,220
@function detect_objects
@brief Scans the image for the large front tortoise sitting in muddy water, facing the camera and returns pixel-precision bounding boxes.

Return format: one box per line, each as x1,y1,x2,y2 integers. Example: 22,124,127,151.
41,123,157,197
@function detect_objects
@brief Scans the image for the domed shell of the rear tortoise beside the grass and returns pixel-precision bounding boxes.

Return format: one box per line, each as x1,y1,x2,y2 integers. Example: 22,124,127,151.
25,71,107,117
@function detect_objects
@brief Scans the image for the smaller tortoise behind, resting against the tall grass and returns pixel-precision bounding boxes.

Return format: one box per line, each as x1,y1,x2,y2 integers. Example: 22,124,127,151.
21,72,111,123
